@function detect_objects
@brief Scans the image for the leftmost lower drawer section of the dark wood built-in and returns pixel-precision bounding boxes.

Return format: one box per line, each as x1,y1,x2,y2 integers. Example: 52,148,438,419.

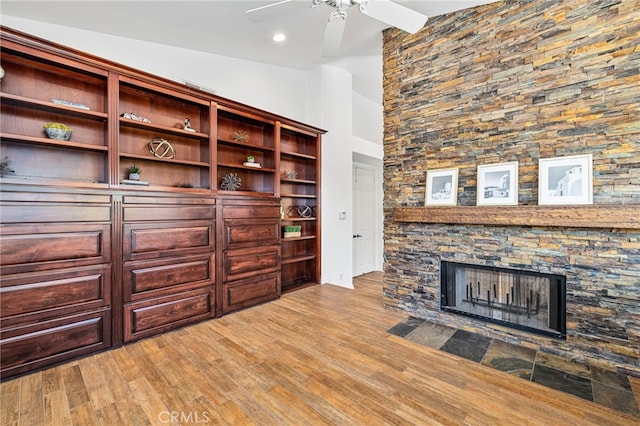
0,185,112,377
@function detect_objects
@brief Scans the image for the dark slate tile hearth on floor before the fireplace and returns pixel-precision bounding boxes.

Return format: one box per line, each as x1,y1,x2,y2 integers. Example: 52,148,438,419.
387,317,640,418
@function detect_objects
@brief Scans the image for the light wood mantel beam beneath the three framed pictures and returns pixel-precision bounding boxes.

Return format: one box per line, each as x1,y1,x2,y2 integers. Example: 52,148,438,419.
393,205,640,229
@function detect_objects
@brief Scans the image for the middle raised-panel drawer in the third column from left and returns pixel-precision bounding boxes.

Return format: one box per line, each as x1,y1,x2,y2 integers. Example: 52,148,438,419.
223,246,280,281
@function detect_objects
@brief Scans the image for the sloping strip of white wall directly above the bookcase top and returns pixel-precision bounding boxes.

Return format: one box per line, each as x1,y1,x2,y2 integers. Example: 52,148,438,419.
2,15,310,126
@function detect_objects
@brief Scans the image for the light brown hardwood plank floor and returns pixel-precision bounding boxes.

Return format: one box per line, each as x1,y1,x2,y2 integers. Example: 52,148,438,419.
0,273,637,426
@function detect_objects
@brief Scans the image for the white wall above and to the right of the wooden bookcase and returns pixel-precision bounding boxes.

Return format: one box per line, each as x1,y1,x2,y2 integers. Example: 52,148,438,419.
2,15,382,287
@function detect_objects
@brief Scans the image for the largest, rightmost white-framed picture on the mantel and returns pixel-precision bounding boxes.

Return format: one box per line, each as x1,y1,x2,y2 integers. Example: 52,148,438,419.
538,154,593,205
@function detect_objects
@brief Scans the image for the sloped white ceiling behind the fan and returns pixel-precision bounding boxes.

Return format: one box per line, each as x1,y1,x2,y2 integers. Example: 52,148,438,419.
1,0,494,103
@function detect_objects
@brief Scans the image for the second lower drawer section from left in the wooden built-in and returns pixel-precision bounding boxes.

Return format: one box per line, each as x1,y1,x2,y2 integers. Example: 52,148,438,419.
122,195,216,342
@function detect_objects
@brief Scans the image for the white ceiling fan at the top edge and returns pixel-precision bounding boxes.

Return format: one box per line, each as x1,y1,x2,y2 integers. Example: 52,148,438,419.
245,0,428,57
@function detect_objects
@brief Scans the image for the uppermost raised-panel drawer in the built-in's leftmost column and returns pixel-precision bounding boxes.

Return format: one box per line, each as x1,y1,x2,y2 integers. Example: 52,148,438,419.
0,223,111,274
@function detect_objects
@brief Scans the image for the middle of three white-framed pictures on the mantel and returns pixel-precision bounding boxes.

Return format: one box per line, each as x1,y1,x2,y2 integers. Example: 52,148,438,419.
476,161,518,206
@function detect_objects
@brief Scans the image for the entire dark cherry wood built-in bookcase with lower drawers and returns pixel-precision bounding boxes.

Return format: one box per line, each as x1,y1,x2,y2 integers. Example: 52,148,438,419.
0,27,324,379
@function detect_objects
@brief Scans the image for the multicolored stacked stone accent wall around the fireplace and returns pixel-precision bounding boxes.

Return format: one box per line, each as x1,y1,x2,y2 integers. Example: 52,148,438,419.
384,0,640,375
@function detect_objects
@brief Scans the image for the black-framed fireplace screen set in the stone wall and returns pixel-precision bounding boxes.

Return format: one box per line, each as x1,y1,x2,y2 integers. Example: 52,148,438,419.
440,262,566,338
